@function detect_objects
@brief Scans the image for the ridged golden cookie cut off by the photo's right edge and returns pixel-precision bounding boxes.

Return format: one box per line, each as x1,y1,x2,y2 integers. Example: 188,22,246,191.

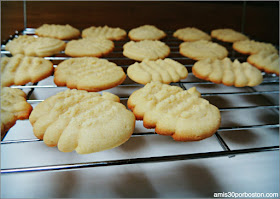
247,50,279,76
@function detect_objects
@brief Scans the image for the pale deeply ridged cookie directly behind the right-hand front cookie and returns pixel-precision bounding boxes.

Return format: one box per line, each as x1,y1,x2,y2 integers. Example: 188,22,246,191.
127,58,188,84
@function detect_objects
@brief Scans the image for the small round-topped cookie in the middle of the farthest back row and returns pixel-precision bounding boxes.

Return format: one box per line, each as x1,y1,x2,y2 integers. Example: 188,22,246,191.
128,25,166,41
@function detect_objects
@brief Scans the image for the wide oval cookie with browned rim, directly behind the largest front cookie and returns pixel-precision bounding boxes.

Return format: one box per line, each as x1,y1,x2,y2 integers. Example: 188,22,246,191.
54,57,126,91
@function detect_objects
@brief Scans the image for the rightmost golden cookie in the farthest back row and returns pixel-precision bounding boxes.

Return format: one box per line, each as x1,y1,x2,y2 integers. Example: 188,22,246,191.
211,28,249,43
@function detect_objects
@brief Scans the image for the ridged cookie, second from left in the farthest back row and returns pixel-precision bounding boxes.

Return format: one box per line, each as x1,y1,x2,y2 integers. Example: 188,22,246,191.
82,26,126,40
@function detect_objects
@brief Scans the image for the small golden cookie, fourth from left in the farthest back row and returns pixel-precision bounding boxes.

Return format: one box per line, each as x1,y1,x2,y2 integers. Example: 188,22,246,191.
173,27,211,41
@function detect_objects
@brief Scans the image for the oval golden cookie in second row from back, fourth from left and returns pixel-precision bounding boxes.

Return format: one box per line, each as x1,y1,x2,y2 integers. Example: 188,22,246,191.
179,40,228,60
